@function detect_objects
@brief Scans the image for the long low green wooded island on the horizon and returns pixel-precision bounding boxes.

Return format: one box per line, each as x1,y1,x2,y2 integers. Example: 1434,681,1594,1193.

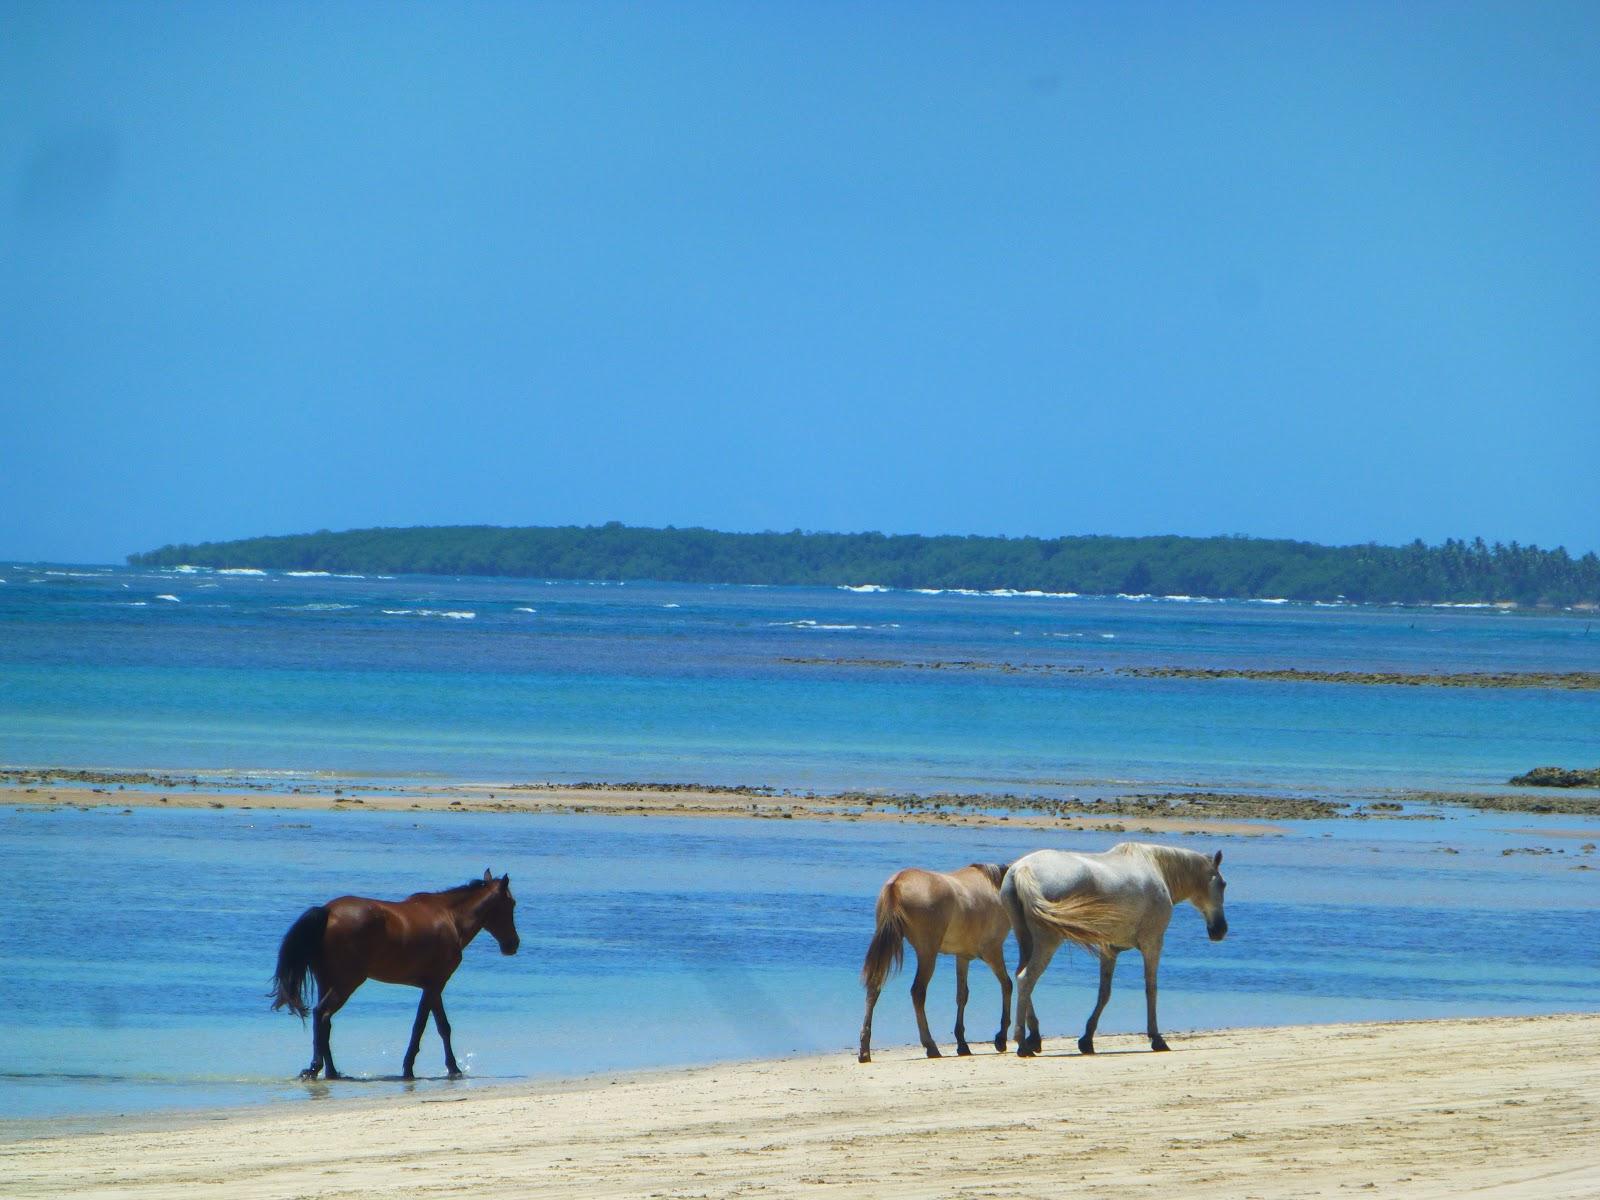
128,522,1600,606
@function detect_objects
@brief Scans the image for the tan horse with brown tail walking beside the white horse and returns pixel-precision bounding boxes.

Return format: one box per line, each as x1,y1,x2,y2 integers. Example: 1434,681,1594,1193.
861,862,1011,1062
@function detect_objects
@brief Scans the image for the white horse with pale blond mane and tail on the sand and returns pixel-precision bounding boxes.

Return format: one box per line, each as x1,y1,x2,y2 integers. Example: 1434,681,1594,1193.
1000,842,1227,1058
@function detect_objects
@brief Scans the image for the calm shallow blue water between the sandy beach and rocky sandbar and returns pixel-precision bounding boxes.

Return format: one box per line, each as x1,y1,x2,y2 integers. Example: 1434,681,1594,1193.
0,806,1600,1118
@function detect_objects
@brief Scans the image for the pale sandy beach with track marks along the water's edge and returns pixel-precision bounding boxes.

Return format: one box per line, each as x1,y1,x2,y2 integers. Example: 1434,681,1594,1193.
0,1014,1600,1200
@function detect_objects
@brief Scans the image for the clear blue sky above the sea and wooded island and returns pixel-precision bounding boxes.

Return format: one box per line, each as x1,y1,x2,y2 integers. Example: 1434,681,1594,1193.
0,0,1600,562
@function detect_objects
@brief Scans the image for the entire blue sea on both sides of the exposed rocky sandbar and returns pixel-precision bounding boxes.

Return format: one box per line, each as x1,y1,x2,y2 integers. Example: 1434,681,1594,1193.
0,566,1600,1128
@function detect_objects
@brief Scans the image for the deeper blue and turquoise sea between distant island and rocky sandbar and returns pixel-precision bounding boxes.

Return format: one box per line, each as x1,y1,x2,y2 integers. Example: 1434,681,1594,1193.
0,566,1600,794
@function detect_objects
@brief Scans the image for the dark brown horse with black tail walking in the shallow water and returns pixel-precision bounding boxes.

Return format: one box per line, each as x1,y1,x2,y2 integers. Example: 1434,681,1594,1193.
269,870,520,1078
